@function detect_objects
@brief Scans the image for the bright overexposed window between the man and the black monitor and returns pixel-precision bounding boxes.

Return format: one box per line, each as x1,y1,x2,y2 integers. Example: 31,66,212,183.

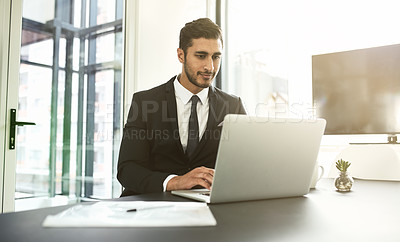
222,0,400,121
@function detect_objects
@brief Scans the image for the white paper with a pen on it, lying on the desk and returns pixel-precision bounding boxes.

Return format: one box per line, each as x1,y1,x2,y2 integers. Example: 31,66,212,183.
43,201,217,227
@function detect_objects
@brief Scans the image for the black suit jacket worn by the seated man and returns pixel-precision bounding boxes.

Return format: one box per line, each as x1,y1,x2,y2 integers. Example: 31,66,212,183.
117,77,246,196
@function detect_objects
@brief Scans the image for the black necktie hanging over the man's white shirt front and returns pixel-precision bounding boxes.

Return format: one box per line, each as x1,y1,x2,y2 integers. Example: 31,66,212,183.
186,95,200,157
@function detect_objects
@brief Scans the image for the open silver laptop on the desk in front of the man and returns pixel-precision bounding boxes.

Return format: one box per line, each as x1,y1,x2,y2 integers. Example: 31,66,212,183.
172,114,326,203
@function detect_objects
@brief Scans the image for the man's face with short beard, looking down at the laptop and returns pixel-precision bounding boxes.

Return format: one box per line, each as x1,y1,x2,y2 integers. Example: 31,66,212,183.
178,38,222,90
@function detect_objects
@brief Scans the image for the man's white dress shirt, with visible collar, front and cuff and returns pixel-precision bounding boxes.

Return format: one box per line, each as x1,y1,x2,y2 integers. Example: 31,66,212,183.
163,76,210,191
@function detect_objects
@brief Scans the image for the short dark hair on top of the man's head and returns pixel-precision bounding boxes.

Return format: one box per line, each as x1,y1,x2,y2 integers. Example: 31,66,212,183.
179,18,224,55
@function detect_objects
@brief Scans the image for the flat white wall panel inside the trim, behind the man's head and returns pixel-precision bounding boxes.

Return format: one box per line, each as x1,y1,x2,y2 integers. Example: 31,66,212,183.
129,0,207,91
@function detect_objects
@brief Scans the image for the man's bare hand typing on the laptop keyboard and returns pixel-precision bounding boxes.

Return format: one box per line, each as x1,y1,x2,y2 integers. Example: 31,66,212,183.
167,166,214,191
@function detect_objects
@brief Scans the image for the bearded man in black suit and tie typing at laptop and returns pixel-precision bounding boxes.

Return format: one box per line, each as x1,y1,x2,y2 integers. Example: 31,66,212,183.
117,18,245,196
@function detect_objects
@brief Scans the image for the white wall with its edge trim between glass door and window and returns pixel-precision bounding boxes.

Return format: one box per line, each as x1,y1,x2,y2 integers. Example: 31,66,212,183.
124,0,215,120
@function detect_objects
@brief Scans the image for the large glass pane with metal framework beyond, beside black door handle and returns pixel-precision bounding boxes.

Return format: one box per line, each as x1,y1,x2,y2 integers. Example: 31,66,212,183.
5,0,123,211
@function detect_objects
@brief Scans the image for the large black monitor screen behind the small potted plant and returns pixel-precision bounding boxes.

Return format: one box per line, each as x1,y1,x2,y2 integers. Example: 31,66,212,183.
312,44,400,134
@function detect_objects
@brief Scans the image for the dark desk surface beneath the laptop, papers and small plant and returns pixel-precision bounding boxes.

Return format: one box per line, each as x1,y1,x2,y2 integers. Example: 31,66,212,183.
0,179,400,242
